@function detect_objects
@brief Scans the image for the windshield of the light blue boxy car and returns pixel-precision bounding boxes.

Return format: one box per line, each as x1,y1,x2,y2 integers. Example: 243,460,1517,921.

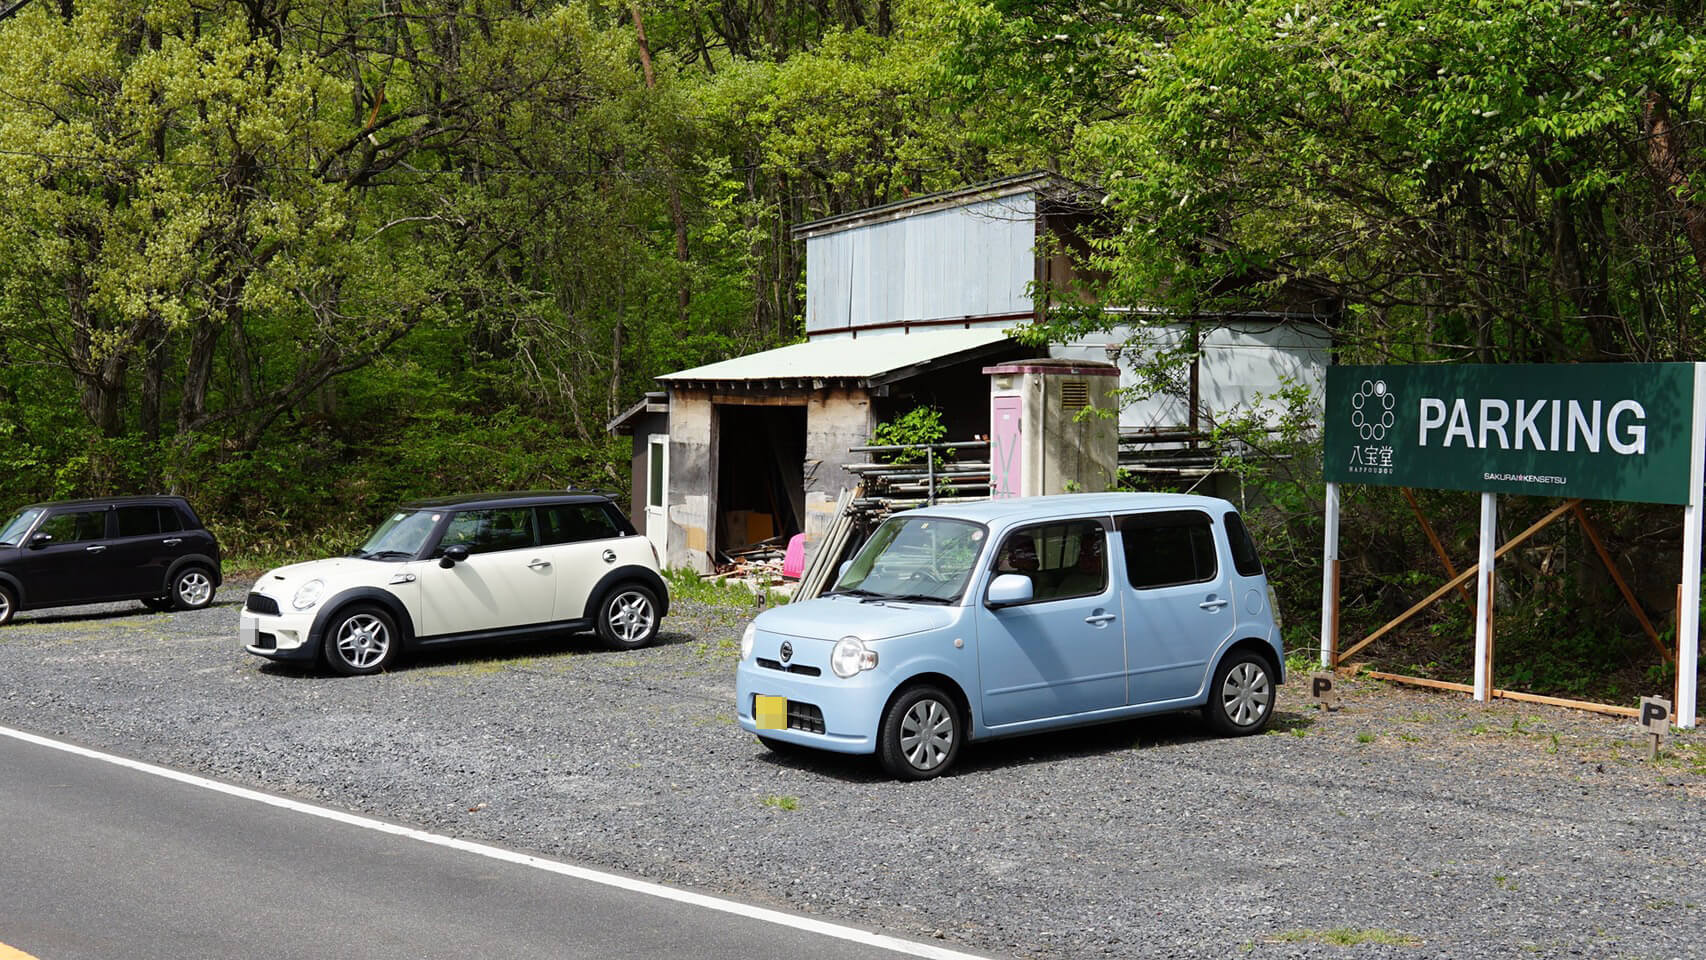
834,517,986,604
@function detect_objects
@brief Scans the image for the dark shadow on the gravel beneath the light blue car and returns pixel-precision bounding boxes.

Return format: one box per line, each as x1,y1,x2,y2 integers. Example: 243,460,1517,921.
752,711,1315,783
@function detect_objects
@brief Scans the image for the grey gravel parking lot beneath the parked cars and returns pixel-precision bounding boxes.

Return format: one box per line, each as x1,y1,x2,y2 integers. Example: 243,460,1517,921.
0,581,1706,958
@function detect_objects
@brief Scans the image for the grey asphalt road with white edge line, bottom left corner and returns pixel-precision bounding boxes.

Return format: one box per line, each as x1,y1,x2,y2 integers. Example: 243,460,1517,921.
0,735,989,960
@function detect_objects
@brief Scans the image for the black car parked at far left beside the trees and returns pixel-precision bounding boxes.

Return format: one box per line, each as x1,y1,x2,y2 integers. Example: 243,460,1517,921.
0,496,222,624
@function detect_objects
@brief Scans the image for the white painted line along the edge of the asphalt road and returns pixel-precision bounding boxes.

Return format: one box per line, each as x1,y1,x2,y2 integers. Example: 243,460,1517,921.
0,726,984,960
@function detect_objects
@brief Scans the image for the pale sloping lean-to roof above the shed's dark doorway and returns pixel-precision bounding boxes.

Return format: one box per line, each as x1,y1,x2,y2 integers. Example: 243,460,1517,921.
659,329,1012,387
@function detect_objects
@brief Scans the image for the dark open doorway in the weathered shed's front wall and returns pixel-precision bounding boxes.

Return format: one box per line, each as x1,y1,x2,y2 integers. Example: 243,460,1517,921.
713,404,805,554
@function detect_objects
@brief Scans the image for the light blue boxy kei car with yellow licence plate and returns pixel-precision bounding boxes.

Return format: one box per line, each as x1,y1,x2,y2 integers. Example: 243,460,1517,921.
735,493,1285,779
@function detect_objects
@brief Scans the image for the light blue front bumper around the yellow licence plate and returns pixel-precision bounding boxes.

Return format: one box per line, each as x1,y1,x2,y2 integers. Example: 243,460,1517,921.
735,641,889,754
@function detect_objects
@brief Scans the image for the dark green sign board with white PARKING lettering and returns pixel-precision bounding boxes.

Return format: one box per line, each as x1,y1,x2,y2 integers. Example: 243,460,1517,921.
1324,363,1694,503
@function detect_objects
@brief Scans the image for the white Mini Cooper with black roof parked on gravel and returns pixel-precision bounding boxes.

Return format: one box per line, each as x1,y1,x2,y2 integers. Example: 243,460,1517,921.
241,491,669,674
